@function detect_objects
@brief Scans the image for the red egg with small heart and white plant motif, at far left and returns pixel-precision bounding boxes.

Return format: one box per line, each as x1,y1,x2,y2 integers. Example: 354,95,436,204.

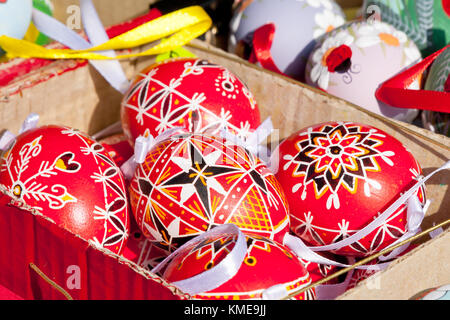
0,125,130,253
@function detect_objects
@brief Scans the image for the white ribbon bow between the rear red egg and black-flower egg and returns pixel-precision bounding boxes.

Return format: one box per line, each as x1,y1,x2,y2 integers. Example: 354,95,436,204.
220,117,274,163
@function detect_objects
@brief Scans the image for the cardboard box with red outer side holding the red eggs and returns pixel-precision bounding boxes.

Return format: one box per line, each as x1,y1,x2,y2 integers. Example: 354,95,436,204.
0,7,450,299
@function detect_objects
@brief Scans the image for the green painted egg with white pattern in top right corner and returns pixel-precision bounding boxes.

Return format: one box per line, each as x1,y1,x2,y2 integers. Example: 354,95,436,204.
363,0,450,56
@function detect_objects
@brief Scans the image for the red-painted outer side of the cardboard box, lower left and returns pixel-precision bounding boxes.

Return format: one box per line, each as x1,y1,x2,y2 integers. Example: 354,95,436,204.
0,194,188,300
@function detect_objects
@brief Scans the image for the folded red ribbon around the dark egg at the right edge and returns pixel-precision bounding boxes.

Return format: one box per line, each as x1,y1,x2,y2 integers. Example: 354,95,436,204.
375,44,450,113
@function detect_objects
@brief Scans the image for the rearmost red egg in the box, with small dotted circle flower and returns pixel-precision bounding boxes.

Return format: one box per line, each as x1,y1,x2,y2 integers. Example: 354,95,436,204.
121,58,261,144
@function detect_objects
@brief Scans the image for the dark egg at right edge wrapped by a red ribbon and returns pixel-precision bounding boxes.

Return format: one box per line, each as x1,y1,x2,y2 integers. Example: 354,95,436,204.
422,44,450,137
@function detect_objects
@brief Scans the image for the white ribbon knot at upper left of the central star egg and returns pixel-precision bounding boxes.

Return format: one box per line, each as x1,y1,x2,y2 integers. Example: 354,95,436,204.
120,127,183,180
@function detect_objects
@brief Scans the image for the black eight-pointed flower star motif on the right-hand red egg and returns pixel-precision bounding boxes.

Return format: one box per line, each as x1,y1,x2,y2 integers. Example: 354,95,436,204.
286,123,394,208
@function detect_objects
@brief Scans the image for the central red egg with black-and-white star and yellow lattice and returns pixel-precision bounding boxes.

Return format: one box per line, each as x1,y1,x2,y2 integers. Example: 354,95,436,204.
129,134,289,251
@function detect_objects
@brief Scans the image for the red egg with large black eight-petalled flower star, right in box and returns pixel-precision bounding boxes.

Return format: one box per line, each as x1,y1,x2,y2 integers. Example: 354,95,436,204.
276,122,425,256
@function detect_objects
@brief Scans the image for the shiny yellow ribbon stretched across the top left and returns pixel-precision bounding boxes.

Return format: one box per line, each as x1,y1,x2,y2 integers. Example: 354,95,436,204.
0,6,212,60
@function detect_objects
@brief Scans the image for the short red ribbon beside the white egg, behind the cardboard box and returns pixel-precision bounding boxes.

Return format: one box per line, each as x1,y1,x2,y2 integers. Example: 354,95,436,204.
249,23,285,75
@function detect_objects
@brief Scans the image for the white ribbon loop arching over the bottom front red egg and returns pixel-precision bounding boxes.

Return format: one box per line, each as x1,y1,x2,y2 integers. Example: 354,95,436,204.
151,224,247,295
